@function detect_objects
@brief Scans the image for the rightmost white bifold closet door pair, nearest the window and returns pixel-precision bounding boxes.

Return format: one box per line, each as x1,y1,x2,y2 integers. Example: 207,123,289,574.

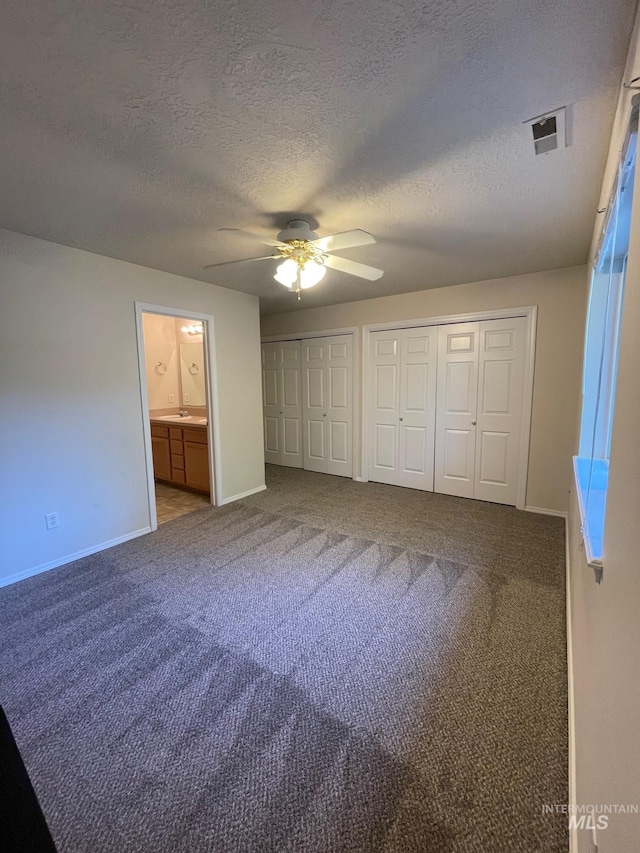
435,317,526,505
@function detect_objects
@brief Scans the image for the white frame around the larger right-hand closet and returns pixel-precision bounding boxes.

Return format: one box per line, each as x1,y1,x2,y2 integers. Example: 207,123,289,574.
362,305,538,510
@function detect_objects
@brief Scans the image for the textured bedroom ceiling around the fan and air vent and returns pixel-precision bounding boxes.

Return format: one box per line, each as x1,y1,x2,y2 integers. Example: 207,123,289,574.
0,0,635,312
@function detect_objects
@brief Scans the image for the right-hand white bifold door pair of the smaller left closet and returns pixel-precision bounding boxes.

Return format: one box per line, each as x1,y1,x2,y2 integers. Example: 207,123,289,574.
301,335,353,477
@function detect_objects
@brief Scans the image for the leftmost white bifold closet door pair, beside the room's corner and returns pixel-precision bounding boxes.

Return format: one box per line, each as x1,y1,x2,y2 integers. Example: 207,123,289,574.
262,341,302,468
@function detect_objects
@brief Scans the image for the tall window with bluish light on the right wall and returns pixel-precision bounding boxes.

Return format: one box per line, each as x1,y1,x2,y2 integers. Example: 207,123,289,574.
573,107,638,566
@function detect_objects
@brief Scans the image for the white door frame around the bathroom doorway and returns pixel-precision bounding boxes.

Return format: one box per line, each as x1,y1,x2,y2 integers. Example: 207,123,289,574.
134,302,222,531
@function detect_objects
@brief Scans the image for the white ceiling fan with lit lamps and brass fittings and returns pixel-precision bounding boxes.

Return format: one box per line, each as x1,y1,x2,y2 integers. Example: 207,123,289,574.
205,219,383,299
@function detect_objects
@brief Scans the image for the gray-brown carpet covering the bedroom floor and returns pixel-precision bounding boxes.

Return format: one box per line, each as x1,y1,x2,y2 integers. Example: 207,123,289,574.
0,468,568,853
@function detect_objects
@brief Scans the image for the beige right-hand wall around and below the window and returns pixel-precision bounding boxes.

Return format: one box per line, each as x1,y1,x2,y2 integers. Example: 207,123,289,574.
569,8,640,853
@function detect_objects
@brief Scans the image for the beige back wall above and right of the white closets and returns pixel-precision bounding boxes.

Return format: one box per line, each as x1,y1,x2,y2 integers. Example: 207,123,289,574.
262,266,587,512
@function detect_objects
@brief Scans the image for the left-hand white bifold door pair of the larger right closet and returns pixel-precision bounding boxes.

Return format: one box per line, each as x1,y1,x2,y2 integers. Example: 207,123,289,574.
367,326,438,492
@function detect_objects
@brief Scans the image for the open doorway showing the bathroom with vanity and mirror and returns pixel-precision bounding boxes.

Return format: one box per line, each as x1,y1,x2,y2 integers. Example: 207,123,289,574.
136,305,216,529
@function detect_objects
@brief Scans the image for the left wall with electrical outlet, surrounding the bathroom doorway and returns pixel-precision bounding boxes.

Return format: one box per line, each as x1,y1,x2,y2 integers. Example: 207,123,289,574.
0,231,264,583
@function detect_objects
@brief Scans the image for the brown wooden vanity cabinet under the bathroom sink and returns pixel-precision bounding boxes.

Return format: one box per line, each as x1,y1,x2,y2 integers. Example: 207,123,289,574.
151,424,211,493
